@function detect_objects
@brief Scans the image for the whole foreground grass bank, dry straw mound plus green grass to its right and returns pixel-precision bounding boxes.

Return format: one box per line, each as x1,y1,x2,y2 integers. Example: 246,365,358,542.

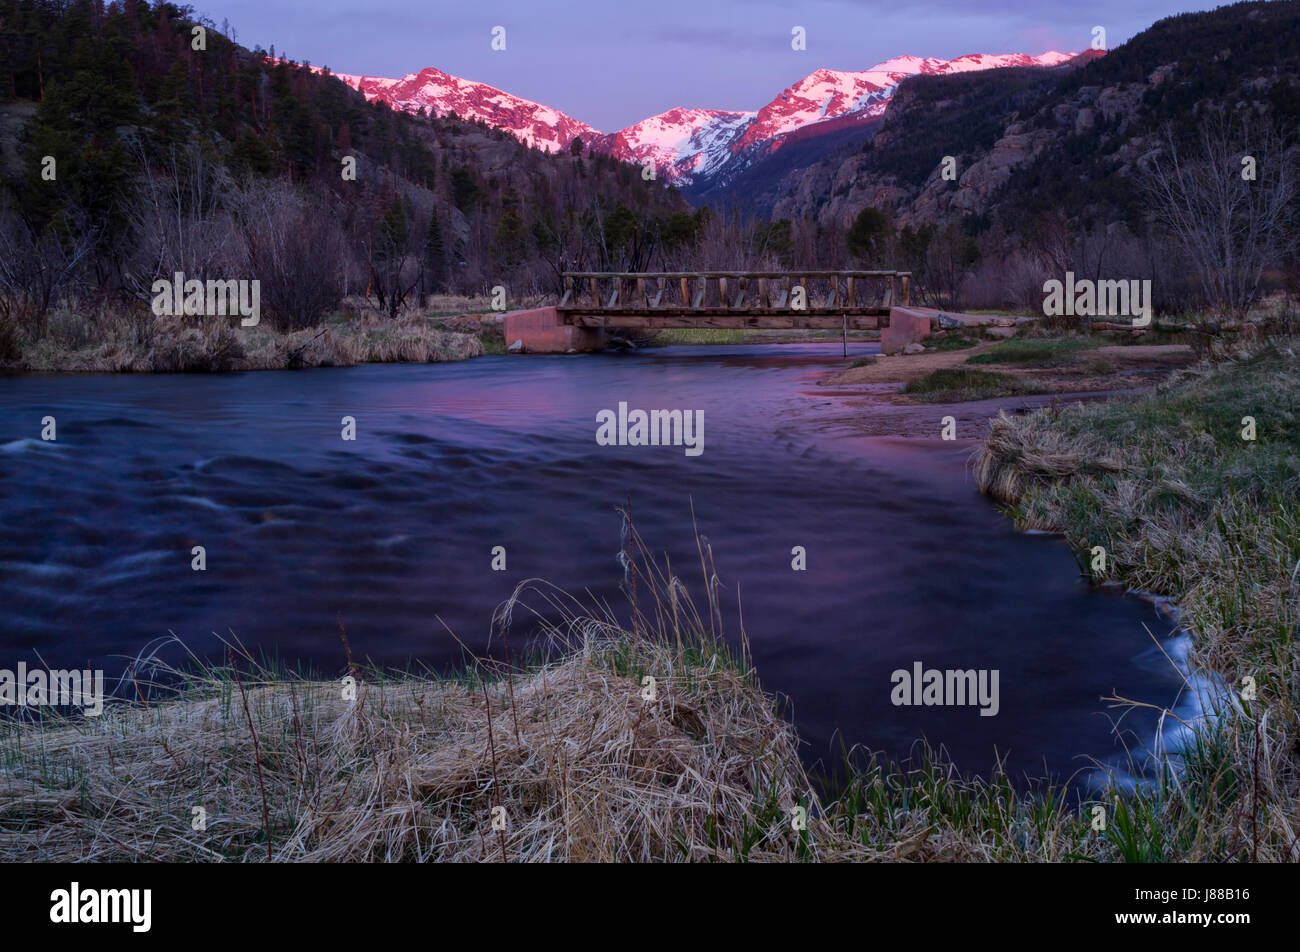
0,517,1138,862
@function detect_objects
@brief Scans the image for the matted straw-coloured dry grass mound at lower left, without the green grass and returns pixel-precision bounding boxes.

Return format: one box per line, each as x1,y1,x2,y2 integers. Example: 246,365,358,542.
0,641,798,861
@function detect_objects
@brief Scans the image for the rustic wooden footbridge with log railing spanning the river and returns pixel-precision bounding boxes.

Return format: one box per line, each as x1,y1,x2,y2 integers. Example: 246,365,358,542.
555,271,911,332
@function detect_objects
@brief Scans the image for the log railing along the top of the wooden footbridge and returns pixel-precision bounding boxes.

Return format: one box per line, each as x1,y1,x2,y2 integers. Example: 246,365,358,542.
559,271,911,313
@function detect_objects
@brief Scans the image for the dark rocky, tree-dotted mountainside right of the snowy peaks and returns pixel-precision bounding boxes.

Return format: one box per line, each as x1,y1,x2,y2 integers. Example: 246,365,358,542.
764,0,1300,233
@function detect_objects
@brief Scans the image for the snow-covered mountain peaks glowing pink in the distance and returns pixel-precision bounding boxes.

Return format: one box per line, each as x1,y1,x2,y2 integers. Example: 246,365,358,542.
334,51,1073,190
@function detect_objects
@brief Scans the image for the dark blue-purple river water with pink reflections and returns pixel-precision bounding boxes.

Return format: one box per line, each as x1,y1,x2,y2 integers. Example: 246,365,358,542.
0,343,1178,776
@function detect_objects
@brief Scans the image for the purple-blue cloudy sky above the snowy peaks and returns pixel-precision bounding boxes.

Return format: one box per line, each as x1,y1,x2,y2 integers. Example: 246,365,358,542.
192,0,1201,131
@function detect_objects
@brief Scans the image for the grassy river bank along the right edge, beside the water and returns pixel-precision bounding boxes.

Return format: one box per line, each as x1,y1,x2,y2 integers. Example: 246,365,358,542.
976,338,1300,862
